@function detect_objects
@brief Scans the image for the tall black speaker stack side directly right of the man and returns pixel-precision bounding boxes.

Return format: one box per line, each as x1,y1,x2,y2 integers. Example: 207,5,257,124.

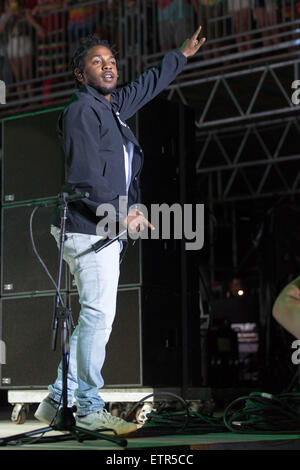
127,98,201,386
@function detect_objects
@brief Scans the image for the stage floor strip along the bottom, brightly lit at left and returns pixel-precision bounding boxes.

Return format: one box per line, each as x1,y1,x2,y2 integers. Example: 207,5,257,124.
0,419,300,452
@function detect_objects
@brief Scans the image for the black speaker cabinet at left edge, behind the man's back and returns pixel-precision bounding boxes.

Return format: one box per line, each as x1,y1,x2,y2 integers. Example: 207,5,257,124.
2,109,64,204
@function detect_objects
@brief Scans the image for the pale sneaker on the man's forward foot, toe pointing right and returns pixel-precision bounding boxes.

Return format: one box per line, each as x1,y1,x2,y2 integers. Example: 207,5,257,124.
76,409,137,435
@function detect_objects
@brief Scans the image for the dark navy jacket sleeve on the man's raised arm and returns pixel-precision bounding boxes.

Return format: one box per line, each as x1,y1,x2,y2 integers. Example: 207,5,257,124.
111,50,187,121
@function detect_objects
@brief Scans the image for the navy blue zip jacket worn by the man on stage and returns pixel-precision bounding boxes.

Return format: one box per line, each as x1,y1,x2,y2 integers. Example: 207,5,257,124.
51,50,187,235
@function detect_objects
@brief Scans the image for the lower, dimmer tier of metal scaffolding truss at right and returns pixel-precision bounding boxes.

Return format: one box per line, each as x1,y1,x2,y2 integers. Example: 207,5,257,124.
196,117,300,202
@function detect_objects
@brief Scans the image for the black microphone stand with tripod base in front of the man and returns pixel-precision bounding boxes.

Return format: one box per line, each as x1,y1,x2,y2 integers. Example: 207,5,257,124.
0,193,127,447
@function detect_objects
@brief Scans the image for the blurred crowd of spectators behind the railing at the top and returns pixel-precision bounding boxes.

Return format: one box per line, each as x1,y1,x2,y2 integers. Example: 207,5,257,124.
0,0,300,103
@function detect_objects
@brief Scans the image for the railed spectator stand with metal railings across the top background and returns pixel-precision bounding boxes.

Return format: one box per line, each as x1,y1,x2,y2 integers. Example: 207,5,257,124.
0,0,300,114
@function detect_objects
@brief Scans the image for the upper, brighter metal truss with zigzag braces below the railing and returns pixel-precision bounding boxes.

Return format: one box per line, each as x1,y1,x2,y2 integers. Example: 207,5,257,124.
168,58,300,131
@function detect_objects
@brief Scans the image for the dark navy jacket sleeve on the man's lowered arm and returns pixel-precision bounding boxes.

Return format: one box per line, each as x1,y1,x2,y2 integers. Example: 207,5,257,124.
62,102,119,217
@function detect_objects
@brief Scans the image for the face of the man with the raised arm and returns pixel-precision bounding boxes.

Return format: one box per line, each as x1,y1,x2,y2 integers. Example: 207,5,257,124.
80,46,118,100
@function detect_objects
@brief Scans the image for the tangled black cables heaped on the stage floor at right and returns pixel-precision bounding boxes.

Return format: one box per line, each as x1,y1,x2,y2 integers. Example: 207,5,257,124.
126,392,300,435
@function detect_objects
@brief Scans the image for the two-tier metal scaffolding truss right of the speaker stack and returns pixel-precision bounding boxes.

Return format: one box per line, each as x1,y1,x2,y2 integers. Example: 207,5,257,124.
163,58,300,203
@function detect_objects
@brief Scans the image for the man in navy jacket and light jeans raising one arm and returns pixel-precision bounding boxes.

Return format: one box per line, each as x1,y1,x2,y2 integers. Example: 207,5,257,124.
35,26,205,435
